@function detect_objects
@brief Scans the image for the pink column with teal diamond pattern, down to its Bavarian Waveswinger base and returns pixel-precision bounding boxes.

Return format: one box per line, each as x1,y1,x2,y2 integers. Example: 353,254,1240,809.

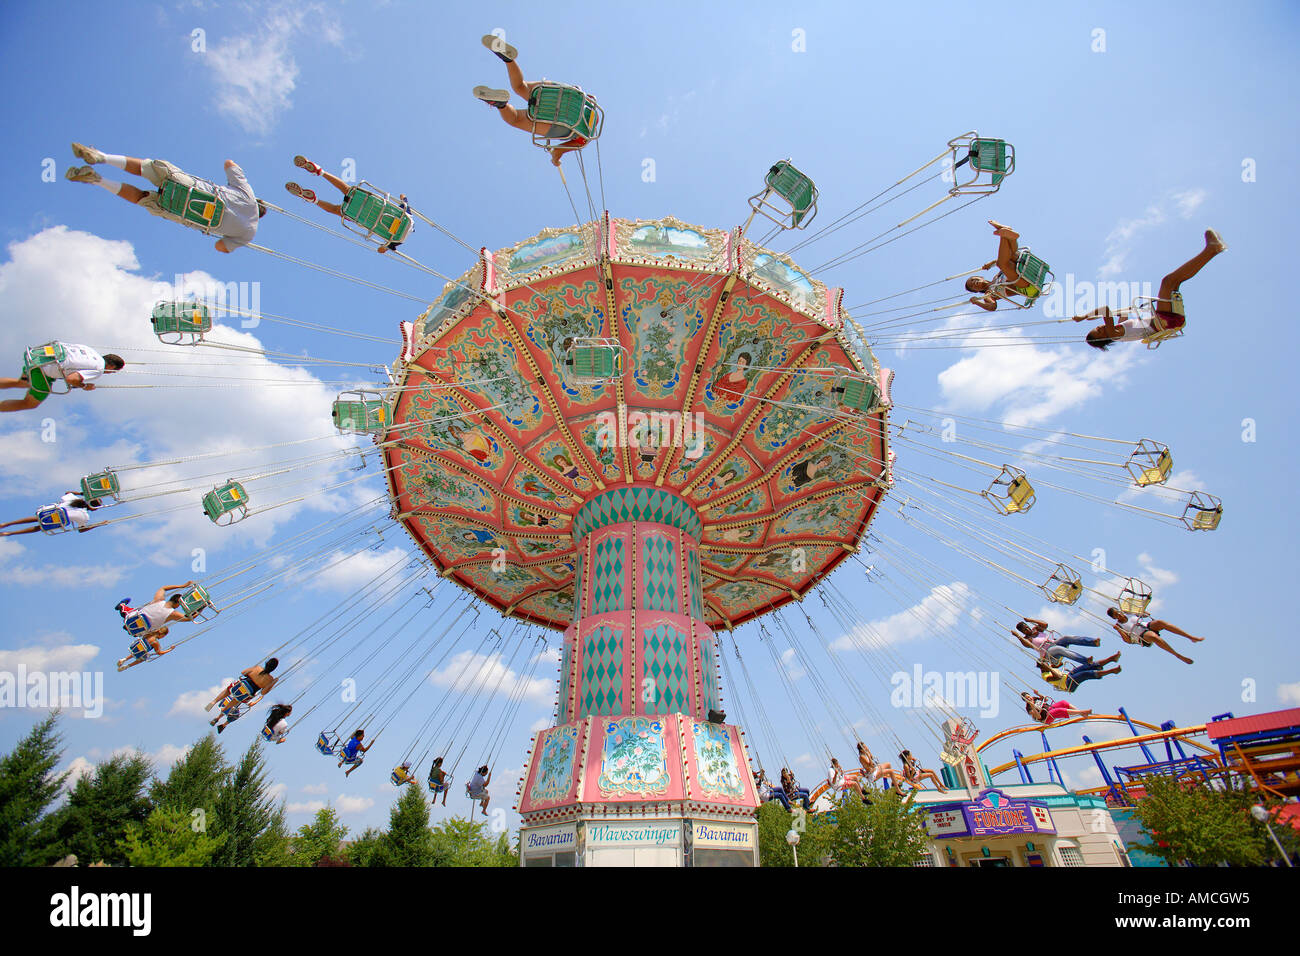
519,485,758,866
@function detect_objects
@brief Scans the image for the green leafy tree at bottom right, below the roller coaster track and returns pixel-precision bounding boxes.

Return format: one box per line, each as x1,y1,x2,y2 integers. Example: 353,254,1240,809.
1134,777,1294,866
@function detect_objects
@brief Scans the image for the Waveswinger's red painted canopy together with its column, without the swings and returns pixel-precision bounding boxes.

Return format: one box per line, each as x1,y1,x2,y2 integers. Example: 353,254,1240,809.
384,215,892,866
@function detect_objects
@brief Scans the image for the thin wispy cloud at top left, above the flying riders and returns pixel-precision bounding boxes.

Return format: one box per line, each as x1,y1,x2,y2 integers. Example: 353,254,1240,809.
202,4,343,135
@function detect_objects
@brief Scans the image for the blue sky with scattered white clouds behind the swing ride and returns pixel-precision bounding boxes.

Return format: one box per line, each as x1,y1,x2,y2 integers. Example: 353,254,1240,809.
0,3,1300,830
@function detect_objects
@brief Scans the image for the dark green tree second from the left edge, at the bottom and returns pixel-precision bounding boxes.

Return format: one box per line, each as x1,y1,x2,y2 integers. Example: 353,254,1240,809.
40,750,153,866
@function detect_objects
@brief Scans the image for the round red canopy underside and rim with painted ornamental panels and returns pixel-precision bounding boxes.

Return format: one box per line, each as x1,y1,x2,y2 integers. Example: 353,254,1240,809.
377,215,891,630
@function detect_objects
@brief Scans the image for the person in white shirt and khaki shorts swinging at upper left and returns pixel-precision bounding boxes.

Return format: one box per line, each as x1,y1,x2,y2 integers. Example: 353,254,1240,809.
66,143,267,252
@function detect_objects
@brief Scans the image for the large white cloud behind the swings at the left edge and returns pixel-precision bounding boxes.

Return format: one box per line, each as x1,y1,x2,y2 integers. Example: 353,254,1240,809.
0,226,373,561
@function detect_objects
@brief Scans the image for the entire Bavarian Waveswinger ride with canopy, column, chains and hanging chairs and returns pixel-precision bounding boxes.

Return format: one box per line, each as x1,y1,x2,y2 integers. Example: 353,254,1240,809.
23,52,1223,865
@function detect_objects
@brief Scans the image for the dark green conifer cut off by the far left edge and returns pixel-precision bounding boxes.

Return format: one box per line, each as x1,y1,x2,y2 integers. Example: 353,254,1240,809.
0,710,68,866
